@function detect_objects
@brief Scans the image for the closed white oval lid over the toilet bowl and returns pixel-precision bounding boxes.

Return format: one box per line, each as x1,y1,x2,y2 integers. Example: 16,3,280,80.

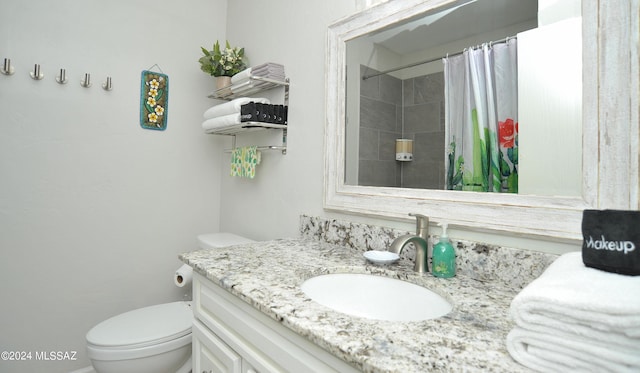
87,302,193,347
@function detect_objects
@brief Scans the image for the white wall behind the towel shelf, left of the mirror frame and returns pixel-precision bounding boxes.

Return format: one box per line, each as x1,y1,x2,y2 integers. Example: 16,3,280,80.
220,0,355,240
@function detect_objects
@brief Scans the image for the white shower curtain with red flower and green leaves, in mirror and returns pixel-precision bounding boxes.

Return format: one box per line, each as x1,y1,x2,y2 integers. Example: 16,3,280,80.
443,39,518,193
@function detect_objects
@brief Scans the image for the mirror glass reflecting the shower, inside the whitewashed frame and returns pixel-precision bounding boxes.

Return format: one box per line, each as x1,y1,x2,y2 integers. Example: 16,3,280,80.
345,0,582,196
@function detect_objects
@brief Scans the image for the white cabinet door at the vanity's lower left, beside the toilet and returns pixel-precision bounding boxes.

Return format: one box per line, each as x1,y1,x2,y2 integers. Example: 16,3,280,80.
192,321,243,373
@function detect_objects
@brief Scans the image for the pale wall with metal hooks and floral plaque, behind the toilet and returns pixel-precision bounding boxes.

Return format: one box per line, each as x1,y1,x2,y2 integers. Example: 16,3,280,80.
0,0,226,373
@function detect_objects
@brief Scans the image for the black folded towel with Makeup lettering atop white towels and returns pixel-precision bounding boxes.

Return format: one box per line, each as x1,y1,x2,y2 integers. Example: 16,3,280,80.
582,210,640,276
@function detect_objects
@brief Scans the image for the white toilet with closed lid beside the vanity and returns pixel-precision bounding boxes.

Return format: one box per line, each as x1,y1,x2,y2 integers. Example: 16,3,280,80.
87,233,254,373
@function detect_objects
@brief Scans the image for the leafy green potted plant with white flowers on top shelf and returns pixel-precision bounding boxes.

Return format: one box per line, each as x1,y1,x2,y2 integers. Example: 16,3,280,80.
198,40,247,89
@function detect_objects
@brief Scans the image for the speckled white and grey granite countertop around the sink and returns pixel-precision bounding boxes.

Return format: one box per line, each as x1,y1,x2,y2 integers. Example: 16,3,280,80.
180,238,528,373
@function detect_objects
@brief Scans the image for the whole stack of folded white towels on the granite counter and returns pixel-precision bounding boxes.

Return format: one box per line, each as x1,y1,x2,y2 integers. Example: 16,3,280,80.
507,252,640,372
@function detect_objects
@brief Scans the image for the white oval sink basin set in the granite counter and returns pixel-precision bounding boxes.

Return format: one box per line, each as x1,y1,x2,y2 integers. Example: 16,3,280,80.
301,273,453,321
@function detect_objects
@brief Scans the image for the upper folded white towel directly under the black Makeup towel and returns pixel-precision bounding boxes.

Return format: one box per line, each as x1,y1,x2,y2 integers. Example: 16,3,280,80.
511,252,640,338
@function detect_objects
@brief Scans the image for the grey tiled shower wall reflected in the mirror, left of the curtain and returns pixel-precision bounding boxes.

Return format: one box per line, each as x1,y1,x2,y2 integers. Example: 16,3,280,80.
358,66,444,189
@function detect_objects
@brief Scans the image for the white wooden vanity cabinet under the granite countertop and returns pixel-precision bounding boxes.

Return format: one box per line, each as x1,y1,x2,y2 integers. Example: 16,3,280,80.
193,273,358,373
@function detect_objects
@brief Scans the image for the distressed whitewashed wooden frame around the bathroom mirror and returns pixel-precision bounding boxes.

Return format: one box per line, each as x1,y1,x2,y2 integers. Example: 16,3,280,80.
325,0,638,242
